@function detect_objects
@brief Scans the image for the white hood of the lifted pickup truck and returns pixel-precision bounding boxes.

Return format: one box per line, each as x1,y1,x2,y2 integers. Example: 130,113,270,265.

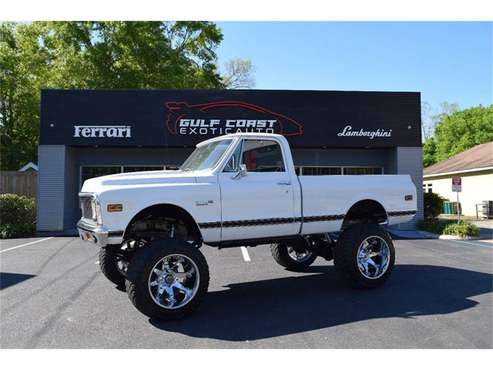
81,171,205,193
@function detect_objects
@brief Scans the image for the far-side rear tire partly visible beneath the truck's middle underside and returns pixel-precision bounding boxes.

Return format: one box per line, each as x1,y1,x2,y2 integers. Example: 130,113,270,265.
270,242,317,271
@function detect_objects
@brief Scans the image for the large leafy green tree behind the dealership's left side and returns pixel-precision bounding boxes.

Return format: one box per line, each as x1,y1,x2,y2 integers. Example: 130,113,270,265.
0,22,224,170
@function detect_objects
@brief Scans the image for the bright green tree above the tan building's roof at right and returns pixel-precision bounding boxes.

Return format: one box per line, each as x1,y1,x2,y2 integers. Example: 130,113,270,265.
435,105,493,161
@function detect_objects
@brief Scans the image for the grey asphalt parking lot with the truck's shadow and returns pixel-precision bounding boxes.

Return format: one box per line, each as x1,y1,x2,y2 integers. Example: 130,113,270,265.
0,237,493,348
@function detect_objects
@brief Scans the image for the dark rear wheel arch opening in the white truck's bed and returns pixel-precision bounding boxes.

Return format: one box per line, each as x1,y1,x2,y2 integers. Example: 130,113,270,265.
341,198,389,229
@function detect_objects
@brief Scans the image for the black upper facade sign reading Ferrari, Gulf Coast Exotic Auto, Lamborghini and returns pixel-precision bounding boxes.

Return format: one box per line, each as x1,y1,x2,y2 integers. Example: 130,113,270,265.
40,89,421,148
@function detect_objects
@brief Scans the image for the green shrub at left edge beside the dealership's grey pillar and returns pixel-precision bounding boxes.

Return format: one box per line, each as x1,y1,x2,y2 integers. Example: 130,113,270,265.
0,194,36,239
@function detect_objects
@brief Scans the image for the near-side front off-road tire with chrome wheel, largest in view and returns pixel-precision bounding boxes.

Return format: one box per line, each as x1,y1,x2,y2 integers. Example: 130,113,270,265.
125,239,209,320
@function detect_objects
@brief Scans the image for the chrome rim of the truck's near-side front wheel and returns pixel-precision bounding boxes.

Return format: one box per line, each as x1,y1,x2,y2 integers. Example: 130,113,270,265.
148,254,200,310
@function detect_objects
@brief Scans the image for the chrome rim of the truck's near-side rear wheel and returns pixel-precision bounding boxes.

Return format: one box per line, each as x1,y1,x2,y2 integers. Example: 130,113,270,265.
357,236,390,279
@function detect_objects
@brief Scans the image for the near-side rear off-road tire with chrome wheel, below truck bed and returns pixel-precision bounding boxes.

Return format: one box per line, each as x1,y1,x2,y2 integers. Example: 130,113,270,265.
334,224,395,288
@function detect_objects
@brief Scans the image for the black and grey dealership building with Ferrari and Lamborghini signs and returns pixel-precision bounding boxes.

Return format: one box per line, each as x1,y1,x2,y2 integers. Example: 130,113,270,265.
37,90,423,231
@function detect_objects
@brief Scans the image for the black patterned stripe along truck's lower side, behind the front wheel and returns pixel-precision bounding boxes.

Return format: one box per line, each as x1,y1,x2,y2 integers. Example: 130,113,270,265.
199,211,416,229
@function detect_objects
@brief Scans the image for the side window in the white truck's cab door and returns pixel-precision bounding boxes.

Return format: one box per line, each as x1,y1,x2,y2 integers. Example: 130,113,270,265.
242,140,285,172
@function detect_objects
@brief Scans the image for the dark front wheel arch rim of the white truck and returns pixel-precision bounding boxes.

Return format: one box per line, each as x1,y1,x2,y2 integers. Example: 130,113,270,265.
123,203,203,242
